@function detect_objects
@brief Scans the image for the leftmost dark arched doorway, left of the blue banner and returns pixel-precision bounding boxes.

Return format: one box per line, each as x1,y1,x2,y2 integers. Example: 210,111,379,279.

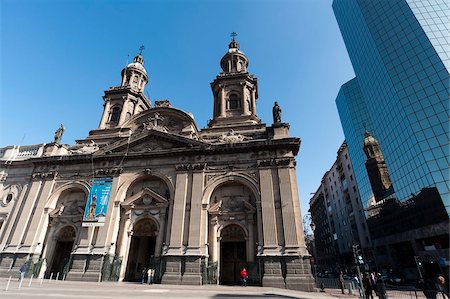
48,225,76,279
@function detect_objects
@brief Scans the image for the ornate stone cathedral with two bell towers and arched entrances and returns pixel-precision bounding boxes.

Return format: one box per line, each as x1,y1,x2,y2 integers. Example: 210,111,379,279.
0,37,314,291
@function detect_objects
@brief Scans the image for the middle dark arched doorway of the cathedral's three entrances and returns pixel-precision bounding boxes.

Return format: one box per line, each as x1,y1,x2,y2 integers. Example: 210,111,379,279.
125,218,158,281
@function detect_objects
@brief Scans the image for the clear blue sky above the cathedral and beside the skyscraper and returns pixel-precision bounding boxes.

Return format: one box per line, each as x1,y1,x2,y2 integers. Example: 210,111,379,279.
0,0,354,220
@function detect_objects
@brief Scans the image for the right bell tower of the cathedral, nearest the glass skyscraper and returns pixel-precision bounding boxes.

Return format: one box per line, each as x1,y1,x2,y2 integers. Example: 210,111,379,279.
209,32,261,128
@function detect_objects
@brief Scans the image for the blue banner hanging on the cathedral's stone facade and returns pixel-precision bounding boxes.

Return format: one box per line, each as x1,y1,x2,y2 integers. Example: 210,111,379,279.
83,178,112,226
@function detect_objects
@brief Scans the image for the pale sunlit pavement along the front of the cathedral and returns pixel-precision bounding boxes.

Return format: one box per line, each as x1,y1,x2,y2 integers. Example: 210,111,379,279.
0,279,356,299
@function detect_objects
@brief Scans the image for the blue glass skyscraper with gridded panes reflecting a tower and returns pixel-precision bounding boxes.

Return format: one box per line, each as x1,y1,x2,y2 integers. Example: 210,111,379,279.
333,0,450,215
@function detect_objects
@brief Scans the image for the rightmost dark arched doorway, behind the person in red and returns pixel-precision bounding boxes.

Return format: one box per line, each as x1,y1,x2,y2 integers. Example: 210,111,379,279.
220,224,247,285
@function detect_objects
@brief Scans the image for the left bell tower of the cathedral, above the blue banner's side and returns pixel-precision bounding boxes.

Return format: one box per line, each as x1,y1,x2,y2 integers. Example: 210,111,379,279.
98,46,150,129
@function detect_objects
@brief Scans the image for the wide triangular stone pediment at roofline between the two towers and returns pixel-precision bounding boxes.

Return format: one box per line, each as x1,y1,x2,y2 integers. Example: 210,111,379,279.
94,129,206,155
